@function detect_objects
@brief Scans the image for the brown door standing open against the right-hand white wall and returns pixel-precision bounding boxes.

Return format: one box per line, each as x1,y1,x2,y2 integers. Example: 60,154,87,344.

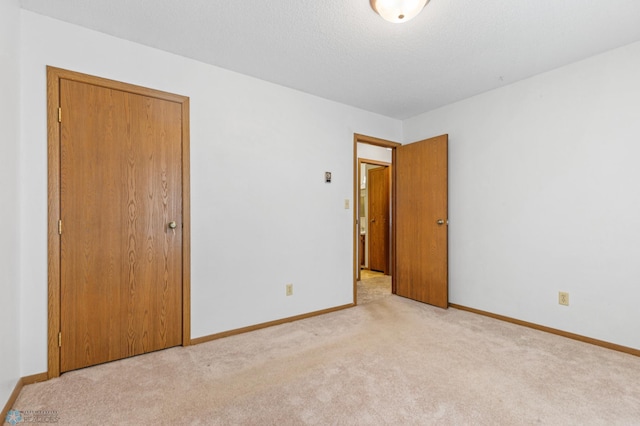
393,135,449,308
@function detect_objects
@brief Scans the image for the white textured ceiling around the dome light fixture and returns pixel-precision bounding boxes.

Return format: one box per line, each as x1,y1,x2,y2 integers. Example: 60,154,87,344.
21,0,640,119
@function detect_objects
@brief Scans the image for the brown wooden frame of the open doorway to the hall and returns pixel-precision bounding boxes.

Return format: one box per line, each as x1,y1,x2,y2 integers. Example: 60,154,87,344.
353,133,402,305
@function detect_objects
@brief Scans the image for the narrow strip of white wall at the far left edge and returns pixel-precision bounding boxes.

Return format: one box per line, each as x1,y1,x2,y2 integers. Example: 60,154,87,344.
0,0,20,406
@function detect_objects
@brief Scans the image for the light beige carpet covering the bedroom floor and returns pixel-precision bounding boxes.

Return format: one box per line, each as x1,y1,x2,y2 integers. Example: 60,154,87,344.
14,283,640,425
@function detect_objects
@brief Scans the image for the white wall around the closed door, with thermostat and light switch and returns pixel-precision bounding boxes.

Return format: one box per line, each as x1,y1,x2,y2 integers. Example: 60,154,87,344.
21,11,402,374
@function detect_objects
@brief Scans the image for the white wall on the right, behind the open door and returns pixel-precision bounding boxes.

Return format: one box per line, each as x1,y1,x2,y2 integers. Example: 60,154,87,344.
403,43,640,349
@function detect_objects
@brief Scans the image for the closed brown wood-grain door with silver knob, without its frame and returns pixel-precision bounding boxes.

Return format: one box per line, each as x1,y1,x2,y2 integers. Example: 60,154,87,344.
60,80,182,372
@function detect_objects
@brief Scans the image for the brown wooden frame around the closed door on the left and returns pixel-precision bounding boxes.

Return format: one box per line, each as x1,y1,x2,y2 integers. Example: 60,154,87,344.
47,66,191,379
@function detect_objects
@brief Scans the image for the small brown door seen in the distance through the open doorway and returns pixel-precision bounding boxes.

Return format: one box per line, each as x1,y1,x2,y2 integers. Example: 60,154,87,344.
367,167,389,274
